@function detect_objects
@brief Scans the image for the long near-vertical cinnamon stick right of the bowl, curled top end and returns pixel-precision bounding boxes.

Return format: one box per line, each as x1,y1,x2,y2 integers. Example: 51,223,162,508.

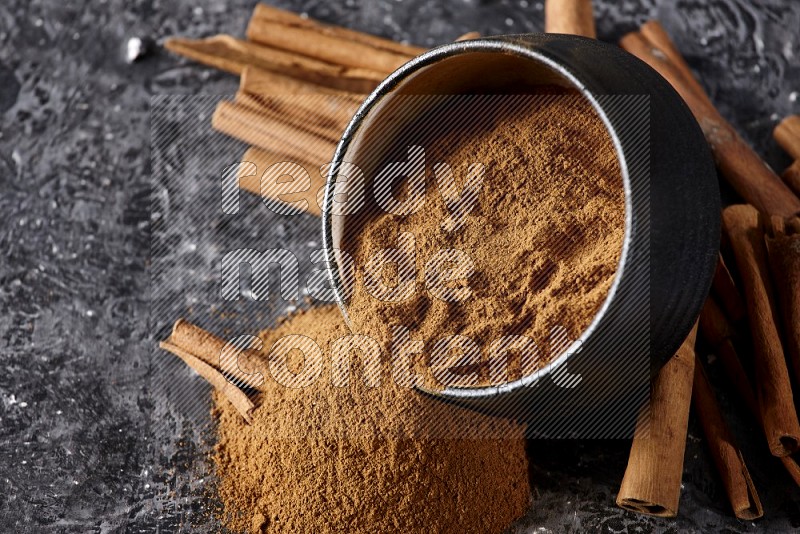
722,205,800,456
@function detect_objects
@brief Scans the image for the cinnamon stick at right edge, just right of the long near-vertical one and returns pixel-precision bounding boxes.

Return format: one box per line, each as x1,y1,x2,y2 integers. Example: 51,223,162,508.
765,217,800,383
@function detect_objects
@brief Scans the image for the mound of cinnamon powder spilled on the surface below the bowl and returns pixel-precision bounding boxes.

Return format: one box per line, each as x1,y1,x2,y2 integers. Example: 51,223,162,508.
213,306,530,533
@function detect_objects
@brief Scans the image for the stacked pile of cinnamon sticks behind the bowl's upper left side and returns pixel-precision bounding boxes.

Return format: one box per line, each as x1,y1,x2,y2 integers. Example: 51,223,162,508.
164,4,478,215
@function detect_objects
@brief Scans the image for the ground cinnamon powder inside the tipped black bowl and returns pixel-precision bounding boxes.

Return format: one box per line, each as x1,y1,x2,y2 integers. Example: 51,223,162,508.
348,94,625,383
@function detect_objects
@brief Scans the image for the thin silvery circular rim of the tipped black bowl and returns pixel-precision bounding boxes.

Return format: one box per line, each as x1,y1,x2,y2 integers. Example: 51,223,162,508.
322,33,633,400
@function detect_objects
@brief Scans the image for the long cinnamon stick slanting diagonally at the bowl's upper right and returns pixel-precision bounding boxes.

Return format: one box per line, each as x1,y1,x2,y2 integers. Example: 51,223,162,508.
620,28,800,217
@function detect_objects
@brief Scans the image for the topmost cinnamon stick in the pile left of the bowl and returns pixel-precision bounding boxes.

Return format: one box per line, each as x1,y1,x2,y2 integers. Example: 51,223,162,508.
250,4,425,57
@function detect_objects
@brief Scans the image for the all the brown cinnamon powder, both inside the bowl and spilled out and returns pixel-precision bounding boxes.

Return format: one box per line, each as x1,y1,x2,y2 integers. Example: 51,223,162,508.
213,95,624,532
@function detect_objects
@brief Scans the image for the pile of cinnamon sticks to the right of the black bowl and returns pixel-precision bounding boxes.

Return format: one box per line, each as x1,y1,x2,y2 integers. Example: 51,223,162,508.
617,15,800,519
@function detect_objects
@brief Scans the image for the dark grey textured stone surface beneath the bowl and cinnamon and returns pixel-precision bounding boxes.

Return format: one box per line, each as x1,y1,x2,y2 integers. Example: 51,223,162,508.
0,0,800,532
